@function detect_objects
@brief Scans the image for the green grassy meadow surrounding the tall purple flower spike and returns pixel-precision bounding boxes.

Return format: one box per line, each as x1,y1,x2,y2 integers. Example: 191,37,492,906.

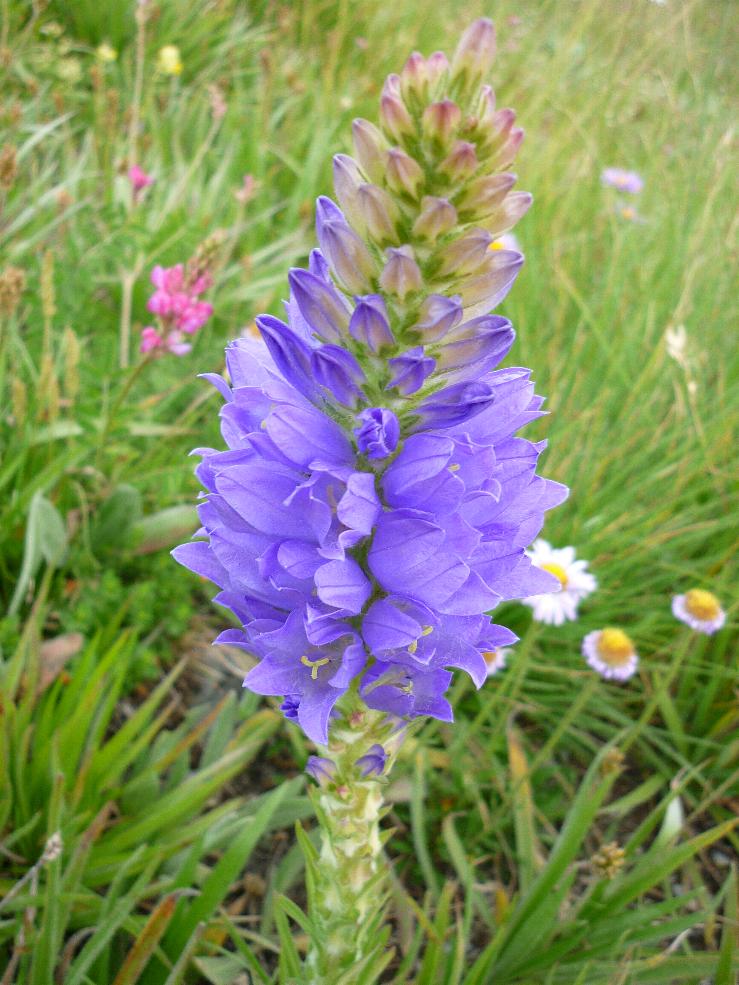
0,0,739,985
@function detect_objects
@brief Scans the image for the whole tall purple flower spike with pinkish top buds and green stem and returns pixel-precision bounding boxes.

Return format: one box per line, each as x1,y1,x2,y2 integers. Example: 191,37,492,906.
175,20,567,972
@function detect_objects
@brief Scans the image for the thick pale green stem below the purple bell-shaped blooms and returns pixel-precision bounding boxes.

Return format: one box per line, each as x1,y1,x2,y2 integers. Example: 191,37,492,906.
306,701,401,985
